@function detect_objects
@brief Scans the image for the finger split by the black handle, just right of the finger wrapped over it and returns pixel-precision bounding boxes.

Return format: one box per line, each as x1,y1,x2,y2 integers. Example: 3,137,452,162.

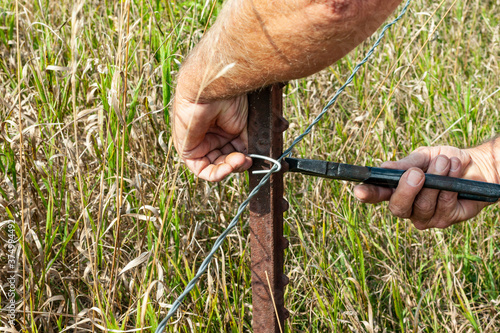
411,155,451,224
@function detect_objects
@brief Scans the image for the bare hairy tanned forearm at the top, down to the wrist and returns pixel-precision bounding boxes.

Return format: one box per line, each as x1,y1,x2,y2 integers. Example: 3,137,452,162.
178,0,401,101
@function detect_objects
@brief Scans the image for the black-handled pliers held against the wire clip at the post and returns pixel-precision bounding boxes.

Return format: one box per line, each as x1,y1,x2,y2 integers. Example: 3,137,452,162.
284,157,500,202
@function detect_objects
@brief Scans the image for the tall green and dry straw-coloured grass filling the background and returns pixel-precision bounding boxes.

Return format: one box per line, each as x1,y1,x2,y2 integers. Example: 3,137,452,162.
0,0,500,332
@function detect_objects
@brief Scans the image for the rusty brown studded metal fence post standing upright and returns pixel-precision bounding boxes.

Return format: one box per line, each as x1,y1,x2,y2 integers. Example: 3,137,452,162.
248,84,288,333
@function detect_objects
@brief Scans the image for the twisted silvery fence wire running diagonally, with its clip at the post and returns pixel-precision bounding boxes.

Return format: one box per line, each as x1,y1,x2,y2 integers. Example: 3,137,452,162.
155,0,411,333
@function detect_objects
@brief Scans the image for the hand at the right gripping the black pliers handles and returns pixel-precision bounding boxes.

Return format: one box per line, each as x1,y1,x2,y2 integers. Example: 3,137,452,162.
354,143,499,230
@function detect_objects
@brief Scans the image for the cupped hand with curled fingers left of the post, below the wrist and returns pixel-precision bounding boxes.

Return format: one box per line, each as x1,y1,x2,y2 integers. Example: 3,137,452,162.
173,91,252,182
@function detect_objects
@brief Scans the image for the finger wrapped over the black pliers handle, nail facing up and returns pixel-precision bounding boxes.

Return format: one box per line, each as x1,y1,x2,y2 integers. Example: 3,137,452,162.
389,168,425,218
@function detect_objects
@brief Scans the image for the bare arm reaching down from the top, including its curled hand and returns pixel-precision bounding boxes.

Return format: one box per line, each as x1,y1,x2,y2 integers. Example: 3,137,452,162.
172,0,401,181
